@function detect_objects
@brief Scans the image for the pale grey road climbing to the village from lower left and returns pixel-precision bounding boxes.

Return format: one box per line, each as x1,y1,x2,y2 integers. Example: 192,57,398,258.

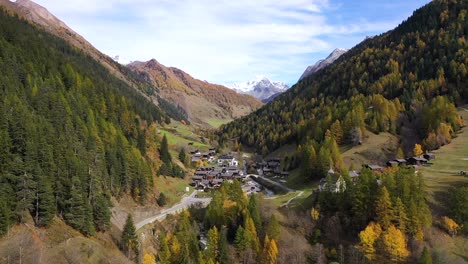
135,190,211,230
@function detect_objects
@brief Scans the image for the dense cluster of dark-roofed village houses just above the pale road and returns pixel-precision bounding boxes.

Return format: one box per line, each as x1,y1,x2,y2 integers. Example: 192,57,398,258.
191,165,246,190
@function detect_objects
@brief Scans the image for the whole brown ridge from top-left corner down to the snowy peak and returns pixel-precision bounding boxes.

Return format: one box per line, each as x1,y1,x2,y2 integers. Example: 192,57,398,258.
0,0,262,127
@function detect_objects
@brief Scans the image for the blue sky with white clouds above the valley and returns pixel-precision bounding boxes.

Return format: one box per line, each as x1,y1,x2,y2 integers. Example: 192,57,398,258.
35,0,429,85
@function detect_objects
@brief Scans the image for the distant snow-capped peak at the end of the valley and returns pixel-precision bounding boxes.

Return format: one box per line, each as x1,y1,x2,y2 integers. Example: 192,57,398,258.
229,77,289,101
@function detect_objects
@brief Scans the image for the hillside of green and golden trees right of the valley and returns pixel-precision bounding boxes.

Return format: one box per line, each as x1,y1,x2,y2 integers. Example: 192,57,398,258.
219,0,468,163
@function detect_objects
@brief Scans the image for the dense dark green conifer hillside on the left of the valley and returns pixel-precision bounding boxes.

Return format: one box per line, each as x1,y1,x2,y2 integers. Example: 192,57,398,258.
0,9,166,235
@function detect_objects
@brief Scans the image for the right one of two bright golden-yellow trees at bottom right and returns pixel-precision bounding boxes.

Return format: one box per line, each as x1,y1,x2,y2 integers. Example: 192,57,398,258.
382,225,409,262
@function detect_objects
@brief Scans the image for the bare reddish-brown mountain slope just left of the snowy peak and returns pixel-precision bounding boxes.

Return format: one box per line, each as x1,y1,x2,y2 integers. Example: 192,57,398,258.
128,59,262,126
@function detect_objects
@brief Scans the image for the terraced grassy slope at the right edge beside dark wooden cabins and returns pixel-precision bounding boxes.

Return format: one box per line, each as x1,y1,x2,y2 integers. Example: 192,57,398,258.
421,106,468,201
